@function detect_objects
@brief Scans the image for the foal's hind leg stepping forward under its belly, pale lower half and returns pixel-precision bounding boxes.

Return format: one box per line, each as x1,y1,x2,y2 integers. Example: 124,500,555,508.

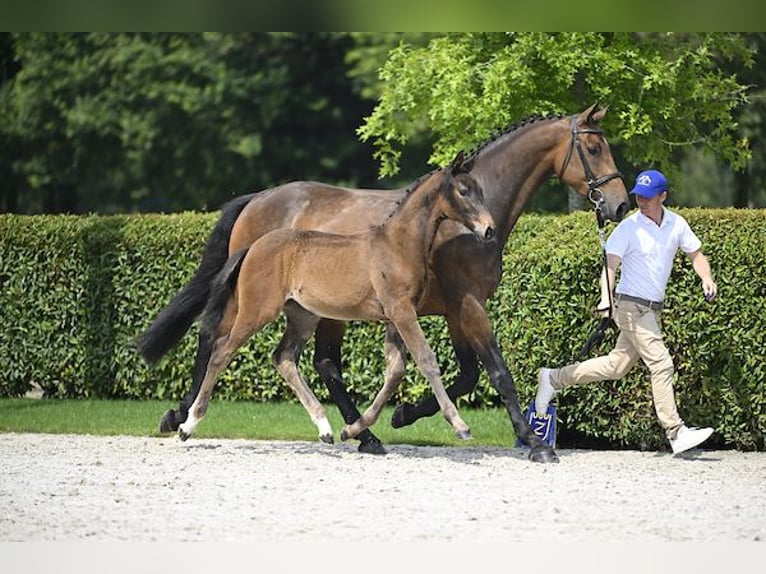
272,301,333,444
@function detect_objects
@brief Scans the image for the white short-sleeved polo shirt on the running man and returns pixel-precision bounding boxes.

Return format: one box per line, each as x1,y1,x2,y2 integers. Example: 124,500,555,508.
606,207,702,302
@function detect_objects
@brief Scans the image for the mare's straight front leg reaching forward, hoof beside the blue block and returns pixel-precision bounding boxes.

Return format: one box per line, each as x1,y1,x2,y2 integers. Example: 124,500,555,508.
460,295,559,462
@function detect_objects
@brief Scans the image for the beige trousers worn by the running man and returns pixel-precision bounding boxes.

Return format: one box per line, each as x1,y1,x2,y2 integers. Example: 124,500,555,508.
551,301,684,439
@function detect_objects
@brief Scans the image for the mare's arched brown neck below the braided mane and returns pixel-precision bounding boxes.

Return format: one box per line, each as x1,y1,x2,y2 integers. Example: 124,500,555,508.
471,120,561,243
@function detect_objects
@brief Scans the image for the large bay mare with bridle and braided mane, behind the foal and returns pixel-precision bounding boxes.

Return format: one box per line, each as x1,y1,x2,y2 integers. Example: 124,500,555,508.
139,105,629,462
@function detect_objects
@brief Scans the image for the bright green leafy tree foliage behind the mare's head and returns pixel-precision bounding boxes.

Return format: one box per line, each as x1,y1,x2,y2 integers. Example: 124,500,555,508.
359,32,754,184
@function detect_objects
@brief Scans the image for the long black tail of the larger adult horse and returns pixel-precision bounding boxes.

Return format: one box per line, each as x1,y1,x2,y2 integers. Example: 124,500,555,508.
138,193,255,365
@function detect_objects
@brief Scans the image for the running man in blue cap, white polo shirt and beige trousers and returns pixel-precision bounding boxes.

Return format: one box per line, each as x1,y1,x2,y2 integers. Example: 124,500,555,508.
535,170,717,454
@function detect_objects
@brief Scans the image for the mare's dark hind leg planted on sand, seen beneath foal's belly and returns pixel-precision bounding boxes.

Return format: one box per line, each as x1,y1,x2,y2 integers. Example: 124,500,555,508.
314,319,386,454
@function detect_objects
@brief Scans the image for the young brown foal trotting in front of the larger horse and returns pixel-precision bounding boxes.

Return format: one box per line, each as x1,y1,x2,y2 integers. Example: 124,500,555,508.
179,153,495,443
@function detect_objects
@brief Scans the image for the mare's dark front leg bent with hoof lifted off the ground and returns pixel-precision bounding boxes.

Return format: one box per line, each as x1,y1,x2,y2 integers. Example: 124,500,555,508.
391,316,479,428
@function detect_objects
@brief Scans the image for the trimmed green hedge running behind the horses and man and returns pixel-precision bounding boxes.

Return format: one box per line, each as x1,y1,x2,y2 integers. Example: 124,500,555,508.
0,209,766,450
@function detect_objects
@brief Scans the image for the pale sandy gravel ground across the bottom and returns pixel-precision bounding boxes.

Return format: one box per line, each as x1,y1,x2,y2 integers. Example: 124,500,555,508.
0,434,766,542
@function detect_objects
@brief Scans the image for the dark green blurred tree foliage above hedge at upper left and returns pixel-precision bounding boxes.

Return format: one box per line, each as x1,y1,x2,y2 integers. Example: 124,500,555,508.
0,33,384,212
